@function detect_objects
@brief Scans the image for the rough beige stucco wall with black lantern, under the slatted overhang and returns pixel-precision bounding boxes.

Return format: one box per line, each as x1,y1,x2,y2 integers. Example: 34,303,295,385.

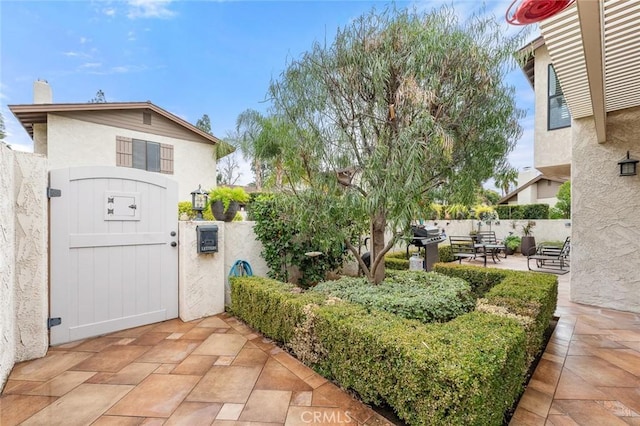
571,108,640,312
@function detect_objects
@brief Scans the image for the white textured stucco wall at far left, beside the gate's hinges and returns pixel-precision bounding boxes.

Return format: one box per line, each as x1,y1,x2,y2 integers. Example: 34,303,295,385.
0,144,49,387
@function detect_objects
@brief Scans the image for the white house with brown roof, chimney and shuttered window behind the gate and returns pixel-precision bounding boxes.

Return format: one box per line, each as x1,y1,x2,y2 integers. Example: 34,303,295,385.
9,81,222,200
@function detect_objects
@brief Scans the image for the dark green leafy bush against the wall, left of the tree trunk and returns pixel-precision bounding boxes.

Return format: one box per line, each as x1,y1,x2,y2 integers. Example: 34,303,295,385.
250,194,344,287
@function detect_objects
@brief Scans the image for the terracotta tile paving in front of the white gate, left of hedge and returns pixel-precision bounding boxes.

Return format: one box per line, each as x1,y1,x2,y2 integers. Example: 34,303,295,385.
0,314,389,426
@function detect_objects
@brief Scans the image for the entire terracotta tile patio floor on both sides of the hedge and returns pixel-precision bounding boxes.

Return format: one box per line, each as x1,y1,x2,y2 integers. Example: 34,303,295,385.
0,256,640,426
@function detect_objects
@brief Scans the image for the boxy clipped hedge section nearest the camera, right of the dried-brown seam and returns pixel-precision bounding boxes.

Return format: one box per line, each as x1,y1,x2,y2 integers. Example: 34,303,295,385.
313,304,526,425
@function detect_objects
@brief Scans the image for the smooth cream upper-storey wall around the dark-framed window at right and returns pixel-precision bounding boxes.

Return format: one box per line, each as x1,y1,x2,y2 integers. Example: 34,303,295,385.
533,46,571,177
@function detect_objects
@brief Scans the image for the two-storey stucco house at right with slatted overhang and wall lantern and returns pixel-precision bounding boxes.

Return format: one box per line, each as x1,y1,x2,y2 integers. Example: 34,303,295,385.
523,0,640,312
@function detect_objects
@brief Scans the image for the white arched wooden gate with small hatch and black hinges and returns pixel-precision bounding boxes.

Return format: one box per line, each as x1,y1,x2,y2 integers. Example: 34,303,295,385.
49,167,178,345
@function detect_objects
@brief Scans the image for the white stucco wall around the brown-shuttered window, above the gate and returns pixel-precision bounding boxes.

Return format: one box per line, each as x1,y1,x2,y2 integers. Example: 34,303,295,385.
47,114,216,201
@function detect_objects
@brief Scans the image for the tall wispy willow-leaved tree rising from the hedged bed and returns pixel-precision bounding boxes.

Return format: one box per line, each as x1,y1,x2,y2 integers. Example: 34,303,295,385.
270,7,521,282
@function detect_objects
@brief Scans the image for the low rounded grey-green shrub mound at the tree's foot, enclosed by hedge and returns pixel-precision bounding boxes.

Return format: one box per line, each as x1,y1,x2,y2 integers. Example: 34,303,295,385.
313,271,475,323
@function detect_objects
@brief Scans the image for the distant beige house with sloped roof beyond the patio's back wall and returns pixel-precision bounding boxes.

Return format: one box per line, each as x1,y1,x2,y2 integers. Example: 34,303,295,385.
498,169,566,207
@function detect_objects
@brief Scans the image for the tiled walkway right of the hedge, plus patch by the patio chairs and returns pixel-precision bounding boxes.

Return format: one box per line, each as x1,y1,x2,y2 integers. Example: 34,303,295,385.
489,256,640,426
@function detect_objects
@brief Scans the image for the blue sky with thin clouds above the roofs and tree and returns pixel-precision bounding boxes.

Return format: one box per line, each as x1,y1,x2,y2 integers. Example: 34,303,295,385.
0,0,536,183
